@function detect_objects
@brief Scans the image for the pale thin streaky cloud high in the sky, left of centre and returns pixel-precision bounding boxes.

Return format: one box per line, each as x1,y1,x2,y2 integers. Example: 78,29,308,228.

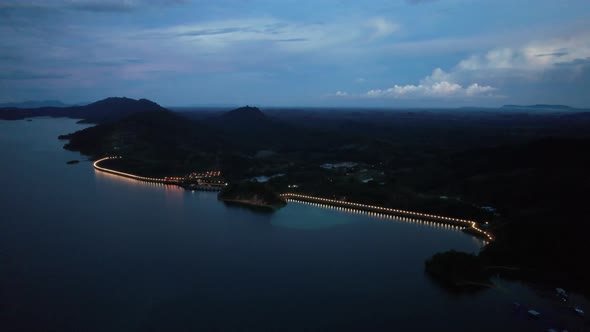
143,17,364,53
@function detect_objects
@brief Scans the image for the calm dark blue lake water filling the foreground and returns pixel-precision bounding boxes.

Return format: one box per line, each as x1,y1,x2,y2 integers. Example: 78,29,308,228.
0,119,588,331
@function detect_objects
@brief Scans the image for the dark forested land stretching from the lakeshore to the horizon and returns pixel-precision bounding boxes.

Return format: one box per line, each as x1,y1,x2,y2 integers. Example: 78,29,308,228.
5,98,590,293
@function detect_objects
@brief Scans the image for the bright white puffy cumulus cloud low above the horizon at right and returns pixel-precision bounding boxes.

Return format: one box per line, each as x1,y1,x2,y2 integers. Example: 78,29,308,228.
365,68,496,98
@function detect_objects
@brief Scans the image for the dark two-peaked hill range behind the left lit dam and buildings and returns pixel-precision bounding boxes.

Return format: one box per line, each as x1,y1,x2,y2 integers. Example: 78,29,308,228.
60,107,366,181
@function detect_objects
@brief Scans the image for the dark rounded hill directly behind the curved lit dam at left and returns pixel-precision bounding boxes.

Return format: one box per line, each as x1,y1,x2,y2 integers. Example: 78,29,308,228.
59,111,231,176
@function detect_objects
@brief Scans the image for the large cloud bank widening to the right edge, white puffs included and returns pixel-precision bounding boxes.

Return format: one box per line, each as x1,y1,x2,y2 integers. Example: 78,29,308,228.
364,32,590,99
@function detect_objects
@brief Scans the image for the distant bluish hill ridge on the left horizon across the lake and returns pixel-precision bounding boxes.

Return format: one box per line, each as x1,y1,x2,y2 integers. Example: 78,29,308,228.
0,97,166,123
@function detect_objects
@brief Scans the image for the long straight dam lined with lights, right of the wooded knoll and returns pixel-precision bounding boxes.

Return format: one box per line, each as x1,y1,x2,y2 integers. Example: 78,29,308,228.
281,193,494,241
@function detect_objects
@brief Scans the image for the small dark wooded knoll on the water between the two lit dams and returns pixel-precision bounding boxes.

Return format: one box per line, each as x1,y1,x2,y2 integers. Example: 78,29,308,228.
217,181,287,211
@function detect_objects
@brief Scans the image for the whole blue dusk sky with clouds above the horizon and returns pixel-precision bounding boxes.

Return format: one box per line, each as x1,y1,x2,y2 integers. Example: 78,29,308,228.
0,0,590,107
